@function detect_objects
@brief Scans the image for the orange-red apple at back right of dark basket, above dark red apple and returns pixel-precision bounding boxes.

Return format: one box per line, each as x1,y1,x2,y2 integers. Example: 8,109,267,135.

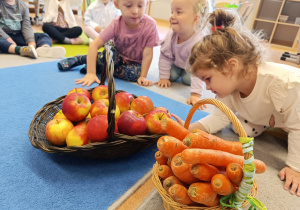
130,96,154,115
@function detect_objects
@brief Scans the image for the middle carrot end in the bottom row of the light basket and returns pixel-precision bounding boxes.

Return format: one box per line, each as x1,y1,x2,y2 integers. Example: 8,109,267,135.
188,182,217,205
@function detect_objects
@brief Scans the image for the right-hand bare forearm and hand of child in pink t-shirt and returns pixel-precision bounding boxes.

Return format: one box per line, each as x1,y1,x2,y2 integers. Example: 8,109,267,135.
137,47,153,86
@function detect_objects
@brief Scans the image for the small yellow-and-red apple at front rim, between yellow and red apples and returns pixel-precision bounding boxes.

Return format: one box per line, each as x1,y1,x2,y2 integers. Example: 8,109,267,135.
66,121,89,147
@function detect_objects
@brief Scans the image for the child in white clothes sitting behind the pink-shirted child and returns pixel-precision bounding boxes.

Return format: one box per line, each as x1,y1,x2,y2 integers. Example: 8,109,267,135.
83,0,121,40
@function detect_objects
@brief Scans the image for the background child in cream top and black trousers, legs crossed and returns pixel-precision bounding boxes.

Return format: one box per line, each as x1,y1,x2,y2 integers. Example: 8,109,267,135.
42,0,84,44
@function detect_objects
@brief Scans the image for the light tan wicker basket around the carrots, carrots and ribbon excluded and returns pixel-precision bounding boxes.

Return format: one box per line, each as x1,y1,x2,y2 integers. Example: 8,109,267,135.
152,99,258,210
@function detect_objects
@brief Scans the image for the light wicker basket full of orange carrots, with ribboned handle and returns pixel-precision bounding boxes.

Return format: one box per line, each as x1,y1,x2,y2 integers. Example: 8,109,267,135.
152,99,266,210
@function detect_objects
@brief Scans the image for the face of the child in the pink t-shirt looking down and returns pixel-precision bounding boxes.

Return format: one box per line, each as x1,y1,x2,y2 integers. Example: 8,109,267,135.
115,0,148,29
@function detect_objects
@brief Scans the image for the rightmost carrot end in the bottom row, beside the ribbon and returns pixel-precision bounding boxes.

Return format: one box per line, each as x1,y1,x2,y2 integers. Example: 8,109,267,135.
211,174,236,195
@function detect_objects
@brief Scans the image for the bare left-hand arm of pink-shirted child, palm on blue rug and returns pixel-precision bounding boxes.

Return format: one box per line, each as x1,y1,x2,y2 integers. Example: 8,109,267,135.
75,37,104,87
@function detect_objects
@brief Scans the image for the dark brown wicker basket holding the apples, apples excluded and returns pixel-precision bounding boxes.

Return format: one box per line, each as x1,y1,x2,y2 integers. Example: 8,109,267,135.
28,45,161,159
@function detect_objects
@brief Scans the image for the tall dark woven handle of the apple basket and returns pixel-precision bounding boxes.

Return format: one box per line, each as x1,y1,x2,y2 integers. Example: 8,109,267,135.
100,44,116,142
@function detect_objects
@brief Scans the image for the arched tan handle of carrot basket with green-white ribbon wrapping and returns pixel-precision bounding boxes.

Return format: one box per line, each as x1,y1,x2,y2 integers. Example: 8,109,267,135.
184,98,255,206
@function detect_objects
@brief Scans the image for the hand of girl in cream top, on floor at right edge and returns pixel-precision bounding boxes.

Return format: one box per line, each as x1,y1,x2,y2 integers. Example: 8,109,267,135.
278,166,300,197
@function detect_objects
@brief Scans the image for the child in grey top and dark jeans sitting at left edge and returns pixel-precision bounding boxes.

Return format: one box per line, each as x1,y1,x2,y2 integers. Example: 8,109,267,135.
0,0,66,58
